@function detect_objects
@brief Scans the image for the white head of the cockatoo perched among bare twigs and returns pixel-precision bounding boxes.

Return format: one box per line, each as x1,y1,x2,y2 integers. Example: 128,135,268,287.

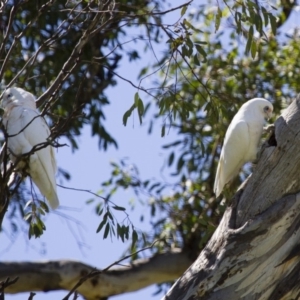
1,87,36,109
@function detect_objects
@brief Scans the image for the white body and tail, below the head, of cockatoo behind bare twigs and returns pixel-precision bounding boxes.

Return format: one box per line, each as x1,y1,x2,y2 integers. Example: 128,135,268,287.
4,106,59,209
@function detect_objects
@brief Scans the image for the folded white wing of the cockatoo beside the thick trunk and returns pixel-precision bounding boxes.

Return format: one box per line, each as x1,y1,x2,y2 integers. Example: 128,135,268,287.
214,120,250,197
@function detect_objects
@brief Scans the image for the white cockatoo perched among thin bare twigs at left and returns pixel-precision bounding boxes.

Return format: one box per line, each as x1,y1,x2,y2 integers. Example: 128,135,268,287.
2,87,59,209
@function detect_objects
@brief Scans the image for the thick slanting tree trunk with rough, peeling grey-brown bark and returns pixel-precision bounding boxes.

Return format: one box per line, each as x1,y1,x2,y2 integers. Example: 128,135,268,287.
164,96,300,300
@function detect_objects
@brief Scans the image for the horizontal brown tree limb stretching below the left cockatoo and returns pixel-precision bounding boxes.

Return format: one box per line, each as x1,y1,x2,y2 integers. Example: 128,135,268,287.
0,253,192,300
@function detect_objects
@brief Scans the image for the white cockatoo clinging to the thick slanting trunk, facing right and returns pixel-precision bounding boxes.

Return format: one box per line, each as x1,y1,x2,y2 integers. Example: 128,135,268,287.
214,98,273,197
